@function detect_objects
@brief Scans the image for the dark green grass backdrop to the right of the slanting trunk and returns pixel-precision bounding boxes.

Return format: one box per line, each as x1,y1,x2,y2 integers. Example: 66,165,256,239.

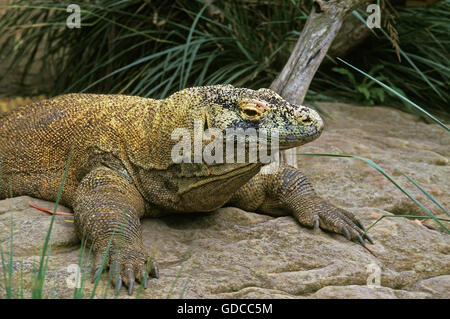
309,1,450,119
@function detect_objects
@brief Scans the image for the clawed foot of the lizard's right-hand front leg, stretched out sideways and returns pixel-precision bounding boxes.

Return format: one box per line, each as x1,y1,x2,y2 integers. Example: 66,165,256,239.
294,203,373,247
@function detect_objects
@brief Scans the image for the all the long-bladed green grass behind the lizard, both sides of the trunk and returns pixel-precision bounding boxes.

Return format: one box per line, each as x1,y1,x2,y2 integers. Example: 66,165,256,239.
0,0,450,120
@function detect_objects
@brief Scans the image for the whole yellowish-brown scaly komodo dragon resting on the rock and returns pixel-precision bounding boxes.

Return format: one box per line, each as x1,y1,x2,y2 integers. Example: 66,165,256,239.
0,85,372,294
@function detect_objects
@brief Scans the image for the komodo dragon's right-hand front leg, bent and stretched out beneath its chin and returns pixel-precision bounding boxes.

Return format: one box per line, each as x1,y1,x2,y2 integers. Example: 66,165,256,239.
227,165,372,246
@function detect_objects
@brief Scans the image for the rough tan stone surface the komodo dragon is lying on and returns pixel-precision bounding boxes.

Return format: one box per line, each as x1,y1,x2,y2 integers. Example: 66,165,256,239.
0,104,450,298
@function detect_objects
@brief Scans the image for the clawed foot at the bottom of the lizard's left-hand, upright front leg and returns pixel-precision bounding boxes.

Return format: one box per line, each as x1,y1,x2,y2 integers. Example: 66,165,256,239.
92,245,159,295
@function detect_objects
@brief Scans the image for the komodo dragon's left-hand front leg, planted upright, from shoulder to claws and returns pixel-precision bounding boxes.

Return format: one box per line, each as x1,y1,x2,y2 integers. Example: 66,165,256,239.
73,167,157,294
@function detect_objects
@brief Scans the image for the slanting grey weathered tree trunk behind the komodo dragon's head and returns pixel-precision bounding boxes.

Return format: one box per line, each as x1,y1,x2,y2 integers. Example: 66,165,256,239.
270,0,371,166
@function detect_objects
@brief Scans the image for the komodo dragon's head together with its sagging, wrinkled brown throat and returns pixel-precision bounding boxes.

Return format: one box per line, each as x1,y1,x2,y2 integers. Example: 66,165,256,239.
151,85,323,211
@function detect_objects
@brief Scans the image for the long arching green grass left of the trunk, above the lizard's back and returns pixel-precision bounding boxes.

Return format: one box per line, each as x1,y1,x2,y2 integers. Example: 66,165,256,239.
0,0,306,97
